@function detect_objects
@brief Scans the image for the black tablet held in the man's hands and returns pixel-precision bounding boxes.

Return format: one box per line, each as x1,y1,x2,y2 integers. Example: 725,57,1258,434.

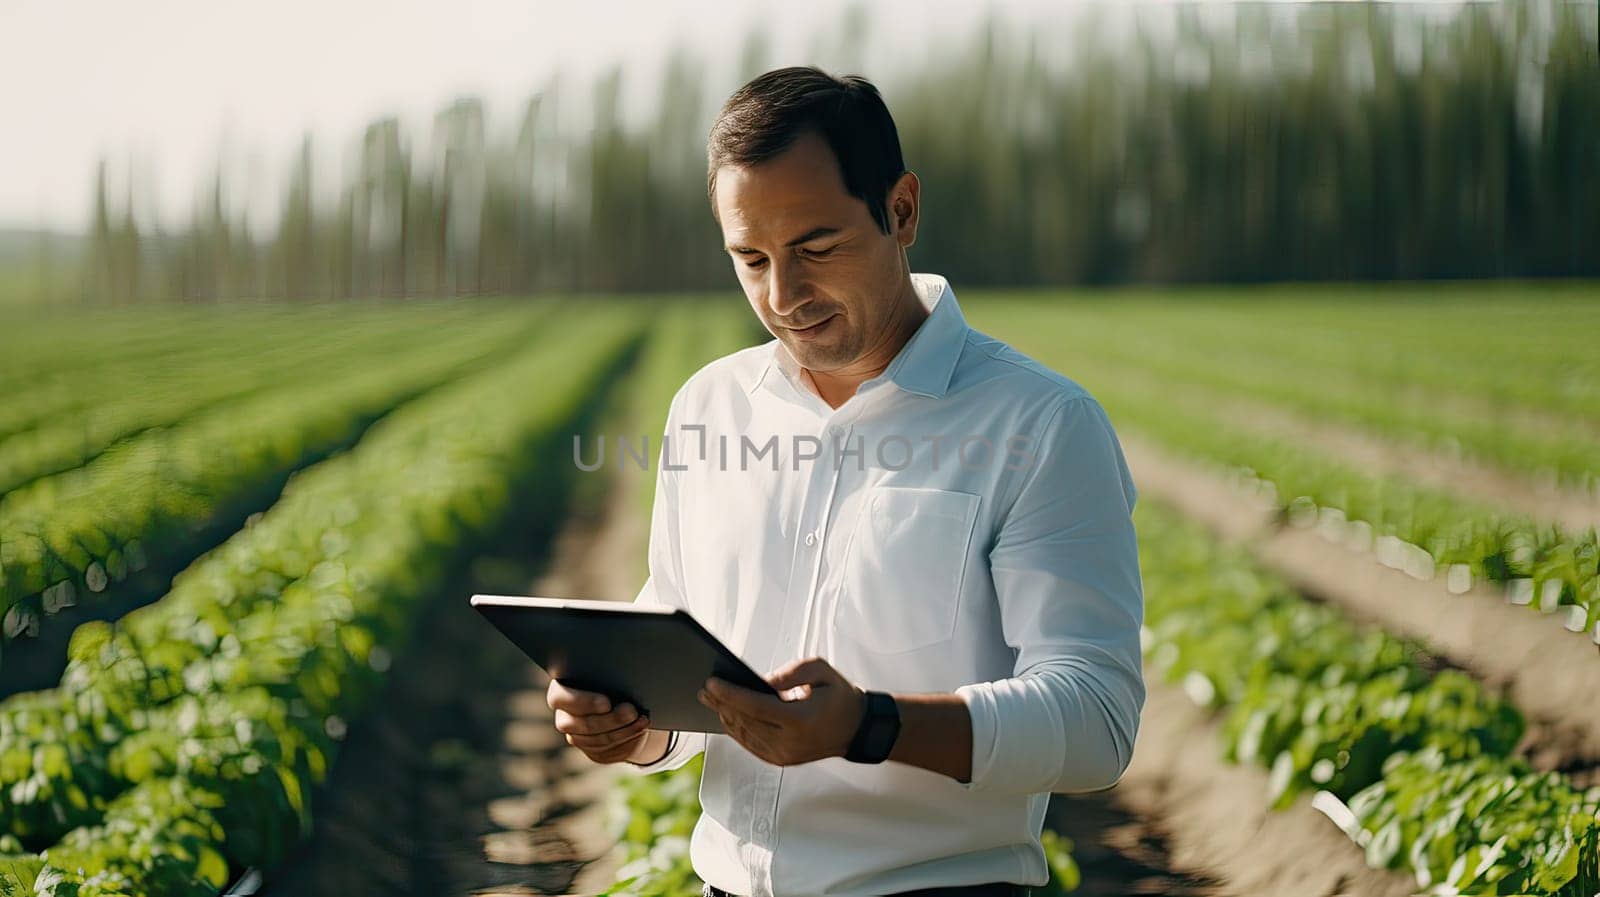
472,595,778,732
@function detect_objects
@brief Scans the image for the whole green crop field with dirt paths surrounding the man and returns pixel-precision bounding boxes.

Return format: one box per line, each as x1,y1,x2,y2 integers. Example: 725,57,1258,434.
0,283,1600,897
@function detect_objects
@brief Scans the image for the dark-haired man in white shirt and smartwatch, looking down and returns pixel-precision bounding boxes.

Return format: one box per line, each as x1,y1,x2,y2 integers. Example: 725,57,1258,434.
549,67,1144,897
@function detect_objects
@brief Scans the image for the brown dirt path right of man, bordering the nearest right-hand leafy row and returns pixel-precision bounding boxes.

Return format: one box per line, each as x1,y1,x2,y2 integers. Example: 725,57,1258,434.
1123,438,1600,777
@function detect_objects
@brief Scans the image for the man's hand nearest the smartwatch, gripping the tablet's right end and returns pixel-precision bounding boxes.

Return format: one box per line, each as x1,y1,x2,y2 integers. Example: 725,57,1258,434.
699,657,867,766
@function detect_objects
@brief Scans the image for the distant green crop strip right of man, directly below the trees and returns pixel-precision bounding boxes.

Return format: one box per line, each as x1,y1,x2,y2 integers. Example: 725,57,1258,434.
966,285,1600,457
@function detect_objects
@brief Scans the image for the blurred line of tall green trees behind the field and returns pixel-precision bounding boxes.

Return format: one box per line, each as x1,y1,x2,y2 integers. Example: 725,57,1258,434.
68,0,1600,302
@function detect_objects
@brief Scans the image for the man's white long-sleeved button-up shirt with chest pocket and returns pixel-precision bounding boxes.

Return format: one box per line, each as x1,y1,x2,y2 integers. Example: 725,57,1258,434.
637,273,1144,897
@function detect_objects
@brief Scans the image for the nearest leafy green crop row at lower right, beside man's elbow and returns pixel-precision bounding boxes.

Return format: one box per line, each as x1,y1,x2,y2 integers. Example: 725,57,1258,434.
1138,502,1600,897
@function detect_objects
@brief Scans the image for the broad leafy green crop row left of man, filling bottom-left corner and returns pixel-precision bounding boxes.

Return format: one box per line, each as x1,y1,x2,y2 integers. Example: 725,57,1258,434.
0,309,637,895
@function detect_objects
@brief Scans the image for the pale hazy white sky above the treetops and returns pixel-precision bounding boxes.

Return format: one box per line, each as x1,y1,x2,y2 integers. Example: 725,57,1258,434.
0,0,1088,230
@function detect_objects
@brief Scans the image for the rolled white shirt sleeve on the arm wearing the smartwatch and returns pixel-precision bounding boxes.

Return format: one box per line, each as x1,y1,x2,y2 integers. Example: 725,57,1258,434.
955,395,1144,793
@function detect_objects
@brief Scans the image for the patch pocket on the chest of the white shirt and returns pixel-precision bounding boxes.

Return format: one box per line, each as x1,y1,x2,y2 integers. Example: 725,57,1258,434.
834,486,978,654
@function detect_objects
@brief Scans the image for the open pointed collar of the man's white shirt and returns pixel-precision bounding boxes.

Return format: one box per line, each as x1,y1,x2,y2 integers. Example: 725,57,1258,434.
746,273,968,398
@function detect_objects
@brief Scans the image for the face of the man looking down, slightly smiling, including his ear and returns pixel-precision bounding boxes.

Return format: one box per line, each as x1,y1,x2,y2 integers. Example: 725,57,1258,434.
715,133,917,373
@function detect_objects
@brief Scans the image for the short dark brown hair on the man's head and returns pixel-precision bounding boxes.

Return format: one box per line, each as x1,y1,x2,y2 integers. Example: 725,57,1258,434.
706,66,906,233
